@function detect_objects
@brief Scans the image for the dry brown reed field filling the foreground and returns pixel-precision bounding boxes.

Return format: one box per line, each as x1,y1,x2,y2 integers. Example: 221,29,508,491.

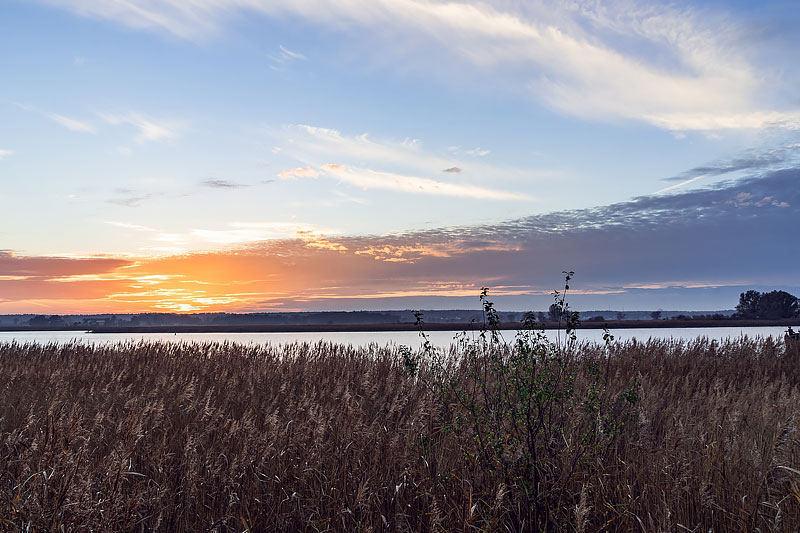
0,339,800,532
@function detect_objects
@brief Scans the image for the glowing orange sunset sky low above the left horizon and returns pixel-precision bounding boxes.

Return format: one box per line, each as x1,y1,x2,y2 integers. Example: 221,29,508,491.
0,236,544,314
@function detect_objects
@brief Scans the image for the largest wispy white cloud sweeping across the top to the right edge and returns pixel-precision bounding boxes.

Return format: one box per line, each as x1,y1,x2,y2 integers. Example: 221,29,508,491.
34,0,798,130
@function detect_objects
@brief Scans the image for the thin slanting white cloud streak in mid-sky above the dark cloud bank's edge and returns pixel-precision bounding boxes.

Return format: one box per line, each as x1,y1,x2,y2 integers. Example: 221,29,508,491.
323,164,531,200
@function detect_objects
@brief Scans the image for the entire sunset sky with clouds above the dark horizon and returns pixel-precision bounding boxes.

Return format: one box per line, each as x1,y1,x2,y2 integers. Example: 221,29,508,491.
0,0,800,314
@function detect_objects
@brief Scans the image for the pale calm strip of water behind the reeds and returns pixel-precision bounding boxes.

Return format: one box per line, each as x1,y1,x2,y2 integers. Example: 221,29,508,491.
0,326,786,347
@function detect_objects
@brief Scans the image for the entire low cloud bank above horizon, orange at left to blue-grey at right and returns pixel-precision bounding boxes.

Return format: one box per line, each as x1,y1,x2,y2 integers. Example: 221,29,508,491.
6,167,800,314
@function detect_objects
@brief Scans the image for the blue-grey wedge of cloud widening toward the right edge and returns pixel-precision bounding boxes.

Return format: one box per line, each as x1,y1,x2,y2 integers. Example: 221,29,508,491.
278,168,800,288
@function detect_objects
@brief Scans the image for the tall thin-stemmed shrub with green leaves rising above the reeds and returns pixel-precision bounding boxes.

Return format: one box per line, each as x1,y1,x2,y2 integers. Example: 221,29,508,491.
406,272,637,531
